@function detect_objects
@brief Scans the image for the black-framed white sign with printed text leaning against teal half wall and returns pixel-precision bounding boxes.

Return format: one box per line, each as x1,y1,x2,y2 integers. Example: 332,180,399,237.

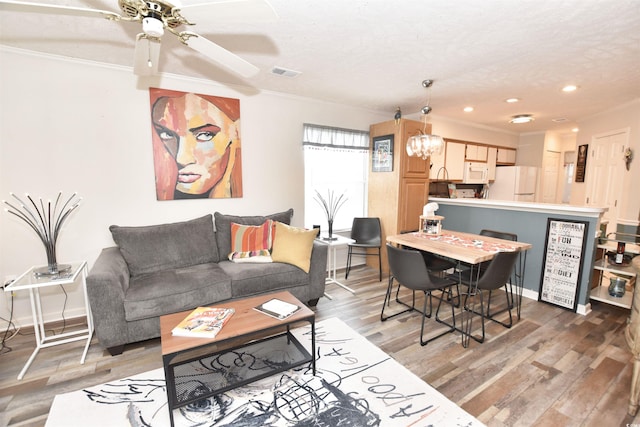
538,219,589,311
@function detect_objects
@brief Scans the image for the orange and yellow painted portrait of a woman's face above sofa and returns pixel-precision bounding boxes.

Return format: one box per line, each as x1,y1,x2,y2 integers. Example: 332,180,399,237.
149,88,242,200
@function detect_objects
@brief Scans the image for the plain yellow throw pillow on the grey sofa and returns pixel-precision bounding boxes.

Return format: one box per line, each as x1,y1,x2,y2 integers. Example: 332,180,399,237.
271,222,318,273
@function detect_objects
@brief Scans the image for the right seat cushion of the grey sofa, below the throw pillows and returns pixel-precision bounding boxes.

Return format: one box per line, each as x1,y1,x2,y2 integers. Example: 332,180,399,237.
218,261,309,298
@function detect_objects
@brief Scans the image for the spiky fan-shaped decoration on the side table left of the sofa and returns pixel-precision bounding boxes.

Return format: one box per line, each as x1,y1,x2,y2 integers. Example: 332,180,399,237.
2,192,82,277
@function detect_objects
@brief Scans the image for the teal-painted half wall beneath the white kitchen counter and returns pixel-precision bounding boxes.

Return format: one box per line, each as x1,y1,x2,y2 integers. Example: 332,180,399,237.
437,203,597,305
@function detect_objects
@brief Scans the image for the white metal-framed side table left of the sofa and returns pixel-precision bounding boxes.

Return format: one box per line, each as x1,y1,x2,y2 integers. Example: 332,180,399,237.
5,261,93,380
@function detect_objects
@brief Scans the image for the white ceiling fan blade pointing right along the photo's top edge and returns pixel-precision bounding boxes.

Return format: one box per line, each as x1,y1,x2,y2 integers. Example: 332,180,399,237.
174,0,278,25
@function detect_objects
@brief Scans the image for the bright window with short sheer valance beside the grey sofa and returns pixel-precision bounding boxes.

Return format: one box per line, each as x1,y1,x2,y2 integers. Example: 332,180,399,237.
302,124,369,232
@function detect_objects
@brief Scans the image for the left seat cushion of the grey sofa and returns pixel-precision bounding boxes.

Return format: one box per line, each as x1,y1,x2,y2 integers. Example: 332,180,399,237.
124,263,232,322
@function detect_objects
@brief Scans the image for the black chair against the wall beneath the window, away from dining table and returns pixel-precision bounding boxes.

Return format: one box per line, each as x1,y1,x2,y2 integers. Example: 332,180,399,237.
344,217,382,281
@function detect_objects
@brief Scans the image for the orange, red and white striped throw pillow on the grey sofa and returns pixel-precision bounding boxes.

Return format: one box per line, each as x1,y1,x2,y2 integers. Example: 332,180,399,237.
228,219,273,262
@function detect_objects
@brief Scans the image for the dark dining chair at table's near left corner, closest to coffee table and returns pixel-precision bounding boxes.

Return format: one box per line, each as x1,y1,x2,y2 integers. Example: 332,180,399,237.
380,244,456,346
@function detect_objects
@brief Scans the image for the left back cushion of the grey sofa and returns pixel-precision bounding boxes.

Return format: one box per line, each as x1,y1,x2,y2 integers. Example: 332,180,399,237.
109,214,220,277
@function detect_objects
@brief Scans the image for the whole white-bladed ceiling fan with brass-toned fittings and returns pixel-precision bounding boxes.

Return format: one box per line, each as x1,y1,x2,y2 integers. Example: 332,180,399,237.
0,0,277,77
